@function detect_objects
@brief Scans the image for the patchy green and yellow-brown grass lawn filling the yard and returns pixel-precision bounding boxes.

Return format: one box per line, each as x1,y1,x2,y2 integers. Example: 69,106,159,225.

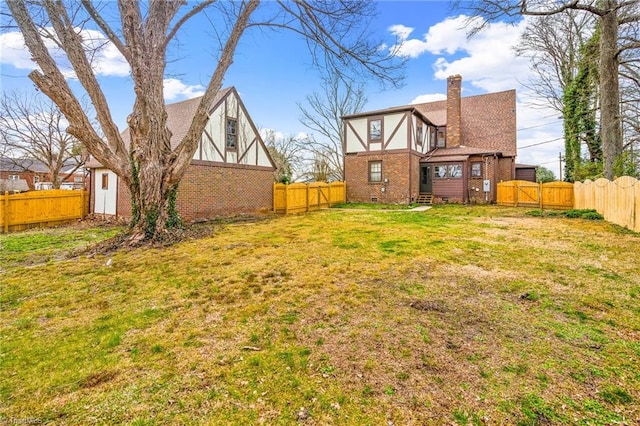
0,205,640,425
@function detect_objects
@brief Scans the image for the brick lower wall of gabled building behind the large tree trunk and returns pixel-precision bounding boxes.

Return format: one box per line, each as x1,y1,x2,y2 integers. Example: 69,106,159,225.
112,162,273,222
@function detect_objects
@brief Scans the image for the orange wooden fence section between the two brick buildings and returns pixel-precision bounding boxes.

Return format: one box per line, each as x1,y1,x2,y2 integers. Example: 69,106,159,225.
273,182,347,214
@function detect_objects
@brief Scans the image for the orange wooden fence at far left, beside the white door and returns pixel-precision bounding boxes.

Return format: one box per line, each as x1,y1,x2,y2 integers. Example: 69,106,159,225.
0,189,89,233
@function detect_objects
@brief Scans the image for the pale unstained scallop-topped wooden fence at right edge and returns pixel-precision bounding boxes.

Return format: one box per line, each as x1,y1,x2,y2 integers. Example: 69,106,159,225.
575,176,640,232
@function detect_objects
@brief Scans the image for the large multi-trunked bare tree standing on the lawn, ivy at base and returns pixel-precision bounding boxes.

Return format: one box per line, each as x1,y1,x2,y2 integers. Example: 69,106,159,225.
7,0,401,242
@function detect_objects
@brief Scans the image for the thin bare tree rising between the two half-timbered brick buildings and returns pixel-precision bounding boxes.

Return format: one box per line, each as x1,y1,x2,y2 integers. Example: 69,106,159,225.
298,73,367,181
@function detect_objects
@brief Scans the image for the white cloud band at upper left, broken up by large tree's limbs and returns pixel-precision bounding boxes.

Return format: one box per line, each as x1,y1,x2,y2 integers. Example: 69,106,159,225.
0,30,129,78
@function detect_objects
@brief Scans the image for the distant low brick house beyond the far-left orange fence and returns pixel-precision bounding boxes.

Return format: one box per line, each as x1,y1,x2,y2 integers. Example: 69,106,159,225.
0,157,86,191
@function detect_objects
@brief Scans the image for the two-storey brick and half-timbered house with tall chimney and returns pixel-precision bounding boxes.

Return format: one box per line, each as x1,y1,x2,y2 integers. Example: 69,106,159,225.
342,75,516,204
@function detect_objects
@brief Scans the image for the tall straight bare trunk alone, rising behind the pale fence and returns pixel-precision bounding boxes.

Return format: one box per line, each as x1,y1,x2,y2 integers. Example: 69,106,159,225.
599,0,623,179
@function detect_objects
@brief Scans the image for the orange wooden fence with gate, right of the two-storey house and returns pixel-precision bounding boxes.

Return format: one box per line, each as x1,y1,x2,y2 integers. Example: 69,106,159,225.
497,180,574,209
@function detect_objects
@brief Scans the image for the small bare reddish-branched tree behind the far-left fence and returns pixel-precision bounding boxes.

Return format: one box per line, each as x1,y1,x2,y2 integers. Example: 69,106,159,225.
0,92,84,189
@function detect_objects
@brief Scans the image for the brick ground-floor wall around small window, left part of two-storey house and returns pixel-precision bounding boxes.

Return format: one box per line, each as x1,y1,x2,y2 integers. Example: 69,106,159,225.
345,151,419,204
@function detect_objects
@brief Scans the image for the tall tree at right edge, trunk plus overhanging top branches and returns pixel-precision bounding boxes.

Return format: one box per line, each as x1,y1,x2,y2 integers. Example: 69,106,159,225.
455,0,640,179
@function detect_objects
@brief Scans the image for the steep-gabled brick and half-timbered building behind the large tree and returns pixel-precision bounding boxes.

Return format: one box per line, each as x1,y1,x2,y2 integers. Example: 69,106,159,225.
88,87,275,221
